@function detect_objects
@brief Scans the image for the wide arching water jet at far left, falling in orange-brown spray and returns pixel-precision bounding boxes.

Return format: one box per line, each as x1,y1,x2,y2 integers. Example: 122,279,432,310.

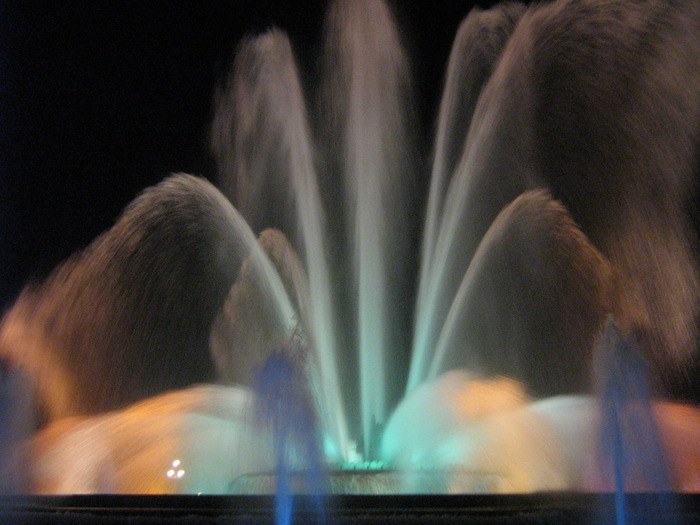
0,174,295,421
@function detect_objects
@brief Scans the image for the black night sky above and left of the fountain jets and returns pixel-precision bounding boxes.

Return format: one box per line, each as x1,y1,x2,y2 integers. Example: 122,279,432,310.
0,0,504,308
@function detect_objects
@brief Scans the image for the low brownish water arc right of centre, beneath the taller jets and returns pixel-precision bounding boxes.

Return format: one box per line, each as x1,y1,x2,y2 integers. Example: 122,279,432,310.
427,190,611,394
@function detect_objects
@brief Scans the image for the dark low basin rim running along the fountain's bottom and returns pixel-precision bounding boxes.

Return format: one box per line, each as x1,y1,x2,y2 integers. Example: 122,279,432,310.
0,492,700,525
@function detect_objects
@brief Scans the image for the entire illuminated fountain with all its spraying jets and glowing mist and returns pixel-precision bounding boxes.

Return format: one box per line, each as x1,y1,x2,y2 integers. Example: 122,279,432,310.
0,0,700,522
